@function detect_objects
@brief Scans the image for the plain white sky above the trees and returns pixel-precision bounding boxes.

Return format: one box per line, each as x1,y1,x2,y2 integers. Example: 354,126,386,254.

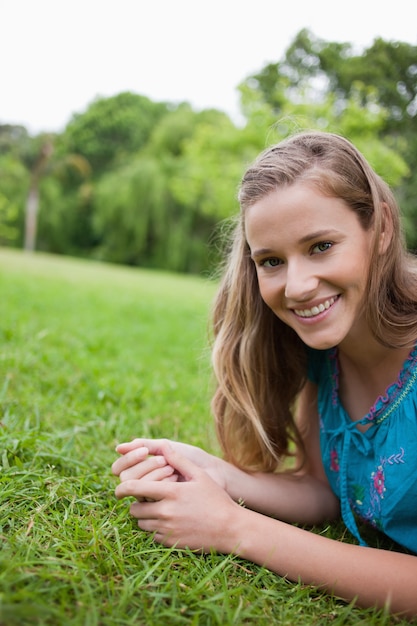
0,0,417,134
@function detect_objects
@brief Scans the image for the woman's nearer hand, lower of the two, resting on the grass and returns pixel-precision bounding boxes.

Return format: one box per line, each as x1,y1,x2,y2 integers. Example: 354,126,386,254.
116,440,242,552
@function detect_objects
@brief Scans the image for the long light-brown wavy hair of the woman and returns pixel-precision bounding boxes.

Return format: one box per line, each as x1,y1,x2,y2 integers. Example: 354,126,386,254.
212,132,417,471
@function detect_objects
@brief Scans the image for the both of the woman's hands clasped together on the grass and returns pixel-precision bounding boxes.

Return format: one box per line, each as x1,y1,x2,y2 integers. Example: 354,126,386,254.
112,439,240,552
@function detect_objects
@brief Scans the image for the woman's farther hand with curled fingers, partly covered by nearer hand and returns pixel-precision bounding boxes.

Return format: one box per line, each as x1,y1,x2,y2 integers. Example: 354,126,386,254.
112,439,228,489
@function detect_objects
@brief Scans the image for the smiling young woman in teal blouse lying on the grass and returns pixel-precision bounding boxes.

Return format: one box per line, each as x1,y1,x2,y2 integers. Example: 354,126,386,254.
112,132,417,617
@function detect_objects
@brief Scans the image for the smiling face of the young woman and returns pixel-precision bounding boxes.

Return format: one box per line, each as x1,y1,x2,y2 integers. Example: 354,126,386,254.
245,182,372,349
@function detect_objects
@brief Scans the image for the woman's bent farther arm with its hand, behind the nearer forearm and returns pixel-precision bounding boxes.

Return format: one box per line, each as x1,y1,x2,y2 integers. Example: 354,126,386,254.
112,383,339,524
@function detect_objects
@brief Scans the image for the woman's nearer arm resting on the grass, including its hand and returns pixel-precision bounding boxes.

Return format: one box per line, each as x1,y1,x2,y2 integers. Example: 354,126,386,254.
116,444,417,617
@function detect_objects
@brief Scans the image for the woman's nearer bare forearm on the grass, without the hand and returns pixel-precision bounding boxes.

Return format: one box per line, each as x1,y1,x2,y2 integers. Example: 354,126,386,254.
228,509,417,618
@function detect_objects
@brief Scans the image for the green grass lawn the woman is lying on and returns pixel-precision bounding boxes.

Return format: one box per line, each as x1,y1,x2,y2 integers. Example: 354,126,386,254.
0,249,405,626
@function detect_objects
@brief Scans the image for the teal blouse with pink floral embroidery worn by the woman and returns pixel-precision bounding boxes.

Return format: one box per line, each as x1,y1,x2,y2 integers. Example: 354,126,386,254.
308,344,417,554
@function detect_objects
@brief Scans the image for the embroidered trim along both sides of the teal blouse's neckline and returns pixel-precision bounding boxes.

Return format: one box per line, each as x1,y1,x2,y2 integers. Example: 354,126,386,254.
329,342,417,424
